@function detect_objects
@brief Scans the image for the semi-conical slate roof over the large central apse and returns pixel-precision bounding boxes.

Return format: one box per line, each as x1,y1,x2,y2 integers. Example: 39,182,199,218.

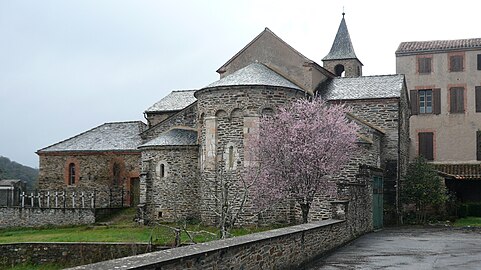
203,63,303,91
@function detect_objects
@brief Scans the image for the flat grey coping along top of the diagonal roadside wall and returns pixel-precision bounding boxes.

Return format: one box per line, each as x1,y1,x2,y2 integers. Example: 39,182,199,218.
71,219,346,270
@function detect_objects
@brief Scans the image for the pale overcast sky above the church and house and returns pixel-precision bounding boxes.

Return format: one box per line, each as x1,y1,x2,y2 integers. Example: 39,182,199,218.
0,0,481,167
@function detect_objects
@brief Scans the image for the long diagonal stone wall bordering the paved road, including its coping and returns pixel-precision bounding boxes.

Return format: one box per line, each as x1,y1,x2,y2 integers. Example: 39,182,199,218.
73,220,356,270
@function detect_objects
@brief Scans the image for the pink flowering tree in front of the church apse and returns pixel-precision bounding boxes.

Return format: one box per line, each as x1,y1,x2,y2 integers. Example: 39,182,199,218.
249,98,358,223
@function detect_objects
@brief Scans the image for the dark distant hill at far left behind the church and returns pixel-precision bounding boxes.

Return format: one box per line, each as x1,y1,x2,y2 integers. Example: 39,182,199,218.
0,156,38,190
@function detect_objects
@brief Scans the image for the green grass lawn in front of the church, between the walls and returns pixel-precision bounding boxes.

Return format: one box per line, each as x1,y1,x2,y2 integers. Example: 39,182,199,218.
0,209,282,246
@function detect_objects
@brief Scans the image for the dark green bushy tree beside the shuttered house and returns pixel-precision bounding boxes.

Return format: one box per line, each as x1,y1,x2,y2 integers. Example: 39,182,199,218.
401,156,448,224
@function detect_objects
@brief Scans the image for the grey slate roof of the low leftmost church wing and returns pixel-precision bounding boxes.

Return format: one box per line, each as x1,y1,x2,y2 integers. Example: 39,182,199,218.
37,121,147,153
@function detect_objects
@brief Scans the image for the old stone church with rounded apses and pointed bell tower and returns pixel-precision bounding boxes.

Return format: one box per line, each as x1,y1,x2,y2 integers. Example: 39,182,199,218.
37,14,409,226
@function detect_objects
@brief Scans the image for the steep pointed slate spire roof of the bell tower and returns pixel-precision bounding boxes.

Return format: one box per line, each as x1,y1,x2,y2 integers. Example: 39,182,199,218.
322,14,357,61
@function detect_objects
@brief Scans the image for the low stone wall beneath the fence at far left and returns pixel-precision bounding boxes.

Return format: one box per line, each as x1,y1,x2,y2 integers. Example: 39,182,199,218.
0,207,95,228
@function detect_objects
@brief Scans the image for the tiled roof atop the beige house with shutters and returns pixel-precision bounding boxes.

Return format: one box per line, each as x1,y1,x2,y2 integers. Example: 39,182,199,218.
396,38,481,55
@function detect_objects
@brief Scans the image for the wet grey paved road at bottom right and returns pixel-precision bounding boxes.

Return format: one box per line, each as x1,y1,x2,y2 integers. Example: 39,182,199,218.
308,228,481,270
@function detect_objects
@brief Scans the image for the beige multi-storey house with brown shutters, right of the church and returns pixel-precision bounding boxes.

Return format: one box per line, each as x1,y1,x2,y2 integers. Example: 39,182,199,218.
396,38,481,201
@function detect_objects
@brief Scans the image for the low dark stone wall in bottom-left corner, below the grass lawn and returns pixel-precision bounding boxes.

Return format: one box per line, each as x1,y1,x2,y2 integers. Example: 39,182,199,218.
0,243,163,269
